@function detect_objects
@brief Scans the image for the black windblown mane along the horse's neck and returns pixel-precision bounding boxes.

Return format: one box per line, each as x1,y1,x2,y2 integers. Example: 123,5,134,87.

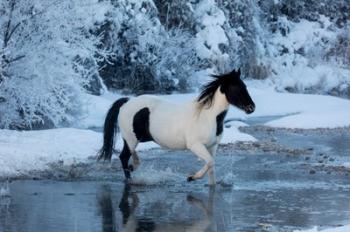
197,70,240,107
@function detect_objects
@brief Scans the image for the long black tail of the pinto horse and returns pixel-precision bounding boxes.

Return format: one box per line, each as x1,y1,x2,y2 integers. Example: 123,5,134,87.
98,97,129,160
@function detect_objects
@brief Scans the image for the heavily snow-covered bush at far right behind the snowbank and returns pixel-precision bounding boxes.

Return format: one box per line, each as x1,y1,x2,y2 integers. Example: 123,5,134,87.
267,12,350,96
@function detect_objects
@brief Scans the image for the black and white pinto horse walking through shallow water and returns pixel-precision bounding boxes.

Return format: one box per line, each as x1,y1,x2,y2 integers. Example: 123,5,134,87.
98,69,255,185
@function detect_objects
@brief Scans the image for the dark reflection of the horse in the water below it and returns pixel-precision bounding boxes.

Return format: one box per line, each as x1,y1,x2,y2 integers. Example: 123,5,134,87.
98,184,216,232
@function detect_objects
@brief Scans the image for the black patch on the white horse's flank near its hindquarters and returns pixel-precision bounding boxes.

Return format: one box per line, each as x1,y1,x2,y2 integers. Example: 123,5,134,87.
132,107,153,142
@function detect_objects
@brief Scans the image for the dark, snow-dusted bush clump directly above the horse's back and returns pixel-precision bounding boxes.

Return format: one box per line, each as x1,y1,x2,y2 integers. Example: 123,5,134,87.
100,0,200,93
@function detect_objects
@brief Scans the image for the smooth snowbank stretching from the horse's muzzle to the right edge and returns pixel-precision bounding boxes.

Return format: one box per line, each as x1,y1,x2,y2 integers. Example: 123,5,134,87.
252,90,350,129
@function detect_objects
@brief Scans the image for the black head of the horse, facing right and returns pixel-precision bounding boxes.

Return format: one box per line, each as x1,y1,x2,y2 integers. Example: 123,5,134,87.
220,69,255,114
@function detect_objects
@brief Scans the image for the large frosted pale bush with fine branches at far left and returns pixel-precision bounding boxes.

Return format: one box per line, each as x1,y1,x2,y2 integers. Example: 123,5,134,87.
0,0,107,129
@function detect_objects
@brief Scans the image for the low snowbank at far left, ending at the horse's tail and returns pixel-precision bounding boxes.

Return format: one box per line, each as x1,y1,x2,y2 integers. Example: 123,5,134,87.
0,128,101,176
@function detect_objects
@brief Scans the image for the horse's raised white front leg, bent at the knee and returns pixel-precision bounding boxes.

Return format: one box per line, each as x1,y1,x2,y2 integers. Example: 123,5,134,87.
187,143,215,185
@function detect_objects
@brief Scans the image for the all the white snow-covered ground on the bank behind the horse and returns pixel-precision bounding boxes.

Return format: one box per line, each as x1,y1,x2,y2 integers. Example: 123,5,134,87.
0,88,350,177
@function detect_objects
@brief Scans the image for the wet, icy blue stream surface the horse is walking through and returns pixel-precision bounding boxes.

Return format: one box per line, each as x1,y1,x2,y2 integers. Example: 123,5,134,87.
0,126,350,232
